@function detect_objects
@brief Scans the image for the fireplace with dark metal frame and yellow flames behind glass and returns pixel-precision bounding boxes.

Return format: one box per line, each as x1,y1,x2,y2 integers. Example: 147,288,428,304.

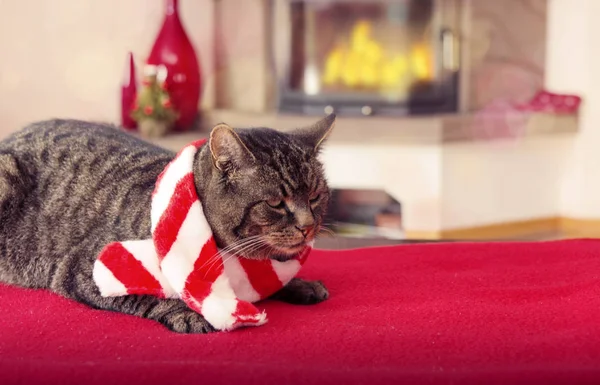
271,0,460,115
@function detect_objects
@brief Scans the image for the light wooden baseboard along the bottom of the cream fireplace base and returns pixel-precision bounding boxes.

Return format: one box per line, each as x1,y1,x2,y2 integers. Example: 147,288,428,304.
406,217,600,240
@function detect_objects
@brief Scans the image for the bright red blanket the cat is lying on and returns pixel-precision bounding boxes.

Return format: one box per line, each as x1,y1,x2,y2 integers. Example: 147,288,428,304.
0,240,600,385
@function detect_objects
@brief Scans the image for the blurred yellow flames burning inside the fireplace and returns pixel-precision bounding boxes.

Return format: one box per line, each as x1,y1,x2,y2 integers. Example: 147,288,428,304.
322,20,433,91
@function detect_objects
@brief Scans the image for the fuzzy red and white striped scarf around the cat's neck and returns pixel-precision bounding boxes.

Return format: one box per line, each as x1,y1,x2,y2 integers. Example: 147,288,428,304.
93,140,312,330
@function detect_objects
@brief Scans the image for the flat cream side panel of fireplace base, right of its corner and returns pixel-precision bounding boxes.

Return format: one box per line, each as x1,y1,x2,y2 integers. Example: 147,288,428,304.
440,134,573,230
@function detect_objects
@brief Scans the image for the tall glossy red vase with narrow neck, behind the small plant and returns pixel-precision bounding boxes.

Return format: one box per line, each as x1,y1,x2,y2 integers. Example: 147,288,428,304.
147,0,202,131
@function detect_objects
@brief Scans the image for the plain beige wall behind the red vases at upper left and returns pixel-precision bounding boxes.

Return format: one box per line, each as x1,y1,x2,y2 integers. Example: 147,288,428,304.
0,0,214,138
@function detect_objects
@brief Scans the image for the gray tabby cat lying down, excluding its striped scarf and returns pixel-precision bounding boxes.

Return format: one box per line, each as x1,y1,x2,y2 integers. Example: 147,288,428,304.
0,115,335,333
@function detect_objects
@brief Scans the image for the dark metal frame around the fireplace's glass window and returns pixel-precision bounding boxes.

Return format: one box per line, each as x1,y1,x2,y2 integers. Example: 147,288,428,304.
269,0,462,116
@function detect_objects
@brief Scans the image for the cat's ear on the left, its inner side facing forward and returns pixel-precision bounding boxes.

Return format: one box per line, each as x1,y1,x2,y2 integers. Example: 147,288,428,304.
209,123,255,172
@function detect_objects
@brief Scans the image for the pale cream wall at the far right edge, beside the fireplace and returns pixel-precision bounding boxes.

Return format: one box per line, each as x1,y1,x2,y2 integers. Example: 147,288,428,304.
547,0,600,219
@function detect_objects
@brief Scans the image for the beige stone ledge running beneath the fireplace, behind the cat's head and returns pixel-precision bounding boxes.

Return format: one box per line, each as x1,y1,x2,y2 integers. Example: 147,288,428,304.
142,110,578,150
